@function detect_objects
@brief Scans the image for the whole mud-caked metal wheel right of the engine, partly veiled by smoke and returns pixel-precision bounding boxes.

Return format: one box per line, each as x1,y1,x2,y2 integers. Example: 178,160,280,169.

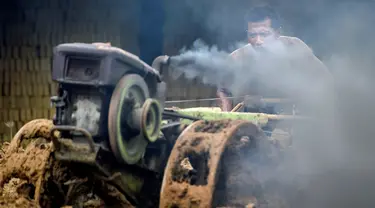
159,120,280,208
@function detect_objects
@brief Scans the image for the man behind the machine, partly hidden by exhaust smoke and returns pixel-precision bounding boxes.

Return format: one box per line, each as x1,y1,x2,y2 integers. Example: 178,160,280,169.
217,7,331,113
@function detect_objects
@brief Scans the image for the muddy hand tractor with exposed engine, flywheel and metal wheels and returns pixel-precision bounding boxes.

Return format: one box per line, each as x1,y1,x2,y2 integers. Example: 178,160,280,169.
0,43,300,208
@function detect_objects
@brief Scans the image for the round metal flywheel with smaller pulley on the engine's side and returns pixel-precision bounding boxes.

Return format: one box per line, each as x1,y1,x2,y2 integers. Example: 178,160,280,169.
108,74,161,164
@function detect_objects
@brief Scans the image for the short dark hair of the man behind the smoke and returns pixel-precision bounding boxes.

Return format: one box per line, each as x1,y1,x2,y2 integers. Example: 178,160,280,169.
245,6,281,29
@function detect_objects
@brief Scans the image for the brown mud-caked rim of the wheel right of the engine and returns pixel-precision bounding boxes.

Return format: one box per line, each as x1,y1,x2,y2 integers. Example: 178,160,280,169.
160,120,253,208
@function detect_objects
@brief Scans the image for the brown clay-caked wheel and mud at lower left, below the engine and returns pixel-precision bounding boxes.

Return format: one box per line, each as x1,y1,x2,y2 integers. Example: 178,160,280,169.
0,119,133,208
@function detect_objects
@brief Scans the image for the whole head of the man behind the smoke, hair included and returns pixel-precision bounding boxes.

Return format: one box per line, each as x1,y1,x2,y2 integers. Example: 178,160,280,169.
246,7,280,47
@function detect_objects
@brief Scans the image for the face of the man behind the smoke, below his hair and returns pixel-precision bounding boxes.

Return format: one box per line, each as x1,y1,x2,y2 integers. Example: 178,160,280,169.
247,18,276,47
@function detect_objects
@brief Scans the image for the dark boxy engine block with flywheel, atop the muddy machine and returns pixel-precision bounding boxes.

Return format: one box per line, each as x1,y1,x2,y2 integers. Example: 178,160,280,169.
51,43,169,169
